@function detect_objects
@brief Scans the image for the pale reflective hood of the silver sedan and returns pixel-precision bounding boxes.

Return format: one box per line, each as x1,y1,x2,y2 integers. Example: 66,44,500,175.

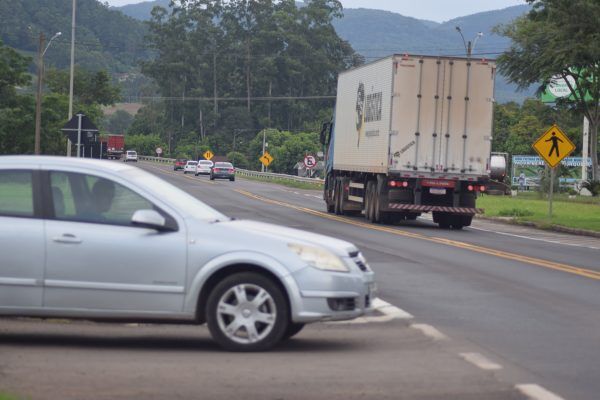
222,220,358,257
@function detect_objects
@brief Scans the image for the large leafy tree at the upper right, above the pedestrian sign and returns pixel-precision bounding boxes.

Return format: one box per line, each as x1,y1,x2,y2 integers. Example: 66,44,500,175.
498,0,600,180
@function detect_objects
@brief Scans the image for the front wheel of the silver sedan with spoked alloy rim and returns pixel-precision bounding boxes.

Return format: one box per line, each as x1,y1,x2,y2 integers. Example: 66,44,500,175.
205,272,290,351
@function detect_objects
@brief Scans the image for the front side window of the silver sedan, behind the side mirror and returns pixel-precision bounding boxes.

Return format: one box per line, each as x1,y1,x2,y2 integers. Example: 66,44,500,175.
50,171,155,225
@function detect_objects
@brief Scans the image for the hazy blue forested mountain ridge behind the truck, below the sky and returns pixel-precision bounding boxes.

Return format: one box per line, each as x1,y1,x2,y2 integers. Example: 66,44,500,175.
115,0,533,102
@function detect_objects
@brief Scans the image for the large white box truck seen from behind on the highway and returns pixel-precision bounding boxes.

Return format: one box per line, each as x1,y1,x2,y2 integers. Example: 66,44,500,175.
321,55,496,229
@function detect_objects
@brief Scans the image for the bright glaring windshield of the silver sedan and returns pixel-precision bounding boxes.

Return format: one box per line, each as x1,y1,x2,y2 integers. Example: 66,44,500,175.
122,168,229,221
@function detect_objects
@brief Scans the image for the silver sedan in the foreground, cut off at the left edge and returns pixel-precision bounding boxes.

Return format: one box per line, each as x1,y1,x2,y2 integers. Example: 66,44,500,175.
0,156,374,351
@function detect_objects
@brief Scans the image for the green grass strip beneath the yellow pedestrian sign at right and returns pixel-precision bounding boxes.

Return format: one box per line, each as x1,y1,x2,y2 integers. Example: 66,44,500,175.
477,192,600,232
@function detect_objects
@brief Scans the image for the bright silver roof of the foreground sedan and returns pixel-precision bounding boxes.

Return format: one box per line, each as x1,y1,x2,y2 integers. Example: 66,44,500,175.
0,155,136,172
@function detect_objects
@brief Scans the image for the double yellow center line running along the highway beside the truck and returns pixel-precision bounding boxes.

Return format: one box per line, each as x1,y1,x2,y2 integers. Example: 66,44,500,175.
235,189,600,280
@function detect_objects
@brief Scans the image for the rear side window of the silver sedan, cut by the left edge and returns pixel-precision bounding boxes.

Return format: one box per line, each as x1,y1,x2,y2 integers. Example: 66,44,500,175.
0,170,34,217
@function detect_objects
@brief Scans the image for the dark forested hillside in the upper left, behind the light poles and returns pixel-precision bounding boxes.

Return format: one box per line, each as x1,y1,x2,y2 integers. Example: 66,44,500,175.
0,0,148,72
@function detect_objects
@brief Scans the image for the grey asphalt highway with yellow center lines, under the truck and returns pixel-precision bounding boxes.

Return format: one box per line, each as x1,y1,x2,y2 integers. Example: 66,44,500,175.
143,164,600,399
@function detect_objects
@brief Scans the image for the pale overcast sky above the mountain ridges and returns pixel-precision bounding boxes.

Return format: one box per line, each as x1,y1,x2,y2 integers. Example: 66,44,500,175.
108,0,525,22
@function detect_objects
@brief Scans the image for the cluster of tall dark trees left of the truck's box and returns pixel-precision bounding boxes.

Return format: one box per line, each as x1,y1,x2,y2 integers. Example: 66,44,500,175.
128,0,363,161
